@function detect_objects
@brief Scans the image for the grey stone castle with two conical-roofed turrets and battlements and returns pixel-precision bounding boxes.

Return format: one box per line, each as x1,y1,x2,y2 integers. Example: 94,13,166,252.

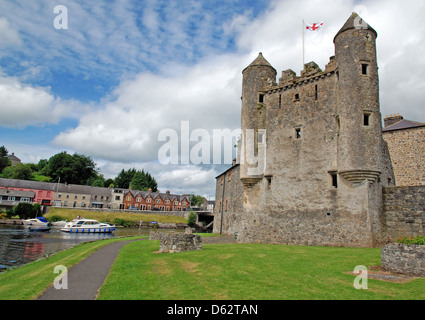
213,13,425,247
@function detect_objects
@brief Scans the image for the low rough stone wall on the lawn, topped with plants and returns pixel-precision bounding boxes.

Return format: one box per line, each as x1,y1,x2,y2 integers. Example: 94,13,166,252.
381,243,425,277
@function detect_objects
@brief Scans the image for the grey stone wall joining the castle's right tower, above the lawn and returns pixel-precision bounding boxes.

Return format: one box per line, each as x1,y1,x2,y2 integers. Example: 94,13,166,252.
383,186,425,241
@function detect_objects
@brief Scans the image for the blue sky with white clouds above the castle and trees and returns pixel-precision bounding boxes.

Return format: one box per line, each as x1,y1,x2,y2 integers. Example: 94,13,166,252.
0,0,425,199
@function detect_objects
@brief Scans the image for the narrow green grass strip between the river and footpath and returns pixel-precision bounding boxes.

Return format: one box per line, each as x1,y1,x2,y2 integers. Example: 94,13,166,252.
0,238,144,300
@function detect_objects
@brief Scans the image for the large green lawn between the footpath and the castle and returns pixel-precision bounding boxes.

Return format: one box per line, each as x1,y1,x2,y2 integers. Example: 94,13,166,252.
98,241,425,300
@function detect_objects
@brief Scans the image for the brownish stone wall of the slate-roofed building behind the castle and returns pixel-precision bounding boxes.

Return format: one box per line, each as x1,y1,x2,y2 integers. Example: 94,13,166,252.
383,127,425,186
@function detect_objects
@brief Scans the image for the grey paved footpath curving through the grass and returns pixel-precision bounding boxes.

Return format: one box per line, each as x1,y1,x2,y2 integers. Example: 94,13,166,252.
38,239,146,300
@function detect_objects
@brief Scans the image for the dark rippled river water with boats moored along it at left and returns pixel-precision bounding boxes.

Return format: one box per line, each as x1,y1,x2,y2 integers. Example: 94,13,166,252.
0,225,150,272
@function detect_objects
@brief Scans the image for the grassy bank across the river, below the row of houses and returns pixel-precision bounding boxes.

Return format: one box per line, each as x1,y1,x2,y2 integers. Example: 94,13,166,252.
45,208,187,224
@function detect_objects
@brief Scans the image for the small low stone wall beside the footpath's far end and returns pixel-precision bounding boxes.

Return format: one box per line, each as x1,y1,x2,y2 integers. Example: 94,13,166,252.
149,231,202,253
